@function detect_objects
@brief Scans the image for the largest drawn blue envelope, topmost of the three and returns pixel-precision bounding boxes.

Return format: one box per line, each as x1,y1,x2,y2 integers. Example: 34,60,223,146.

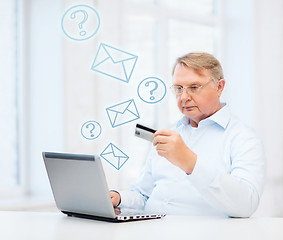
91,43,138,82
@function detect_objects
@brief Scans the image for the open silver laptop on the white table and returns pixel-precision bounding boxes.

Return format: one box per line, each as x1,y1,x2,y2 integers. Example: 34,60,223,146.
42,152,165,222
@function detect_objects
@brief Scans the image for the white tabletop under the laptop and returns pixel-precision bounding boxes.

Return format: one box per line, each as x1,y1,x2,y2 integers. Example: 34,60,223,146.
0,211,283,240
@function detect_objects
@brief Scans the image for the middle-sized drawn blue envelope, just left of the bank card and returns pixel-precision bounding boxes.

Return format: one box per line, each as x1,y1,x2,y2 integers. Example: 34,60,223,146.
106,99,140,128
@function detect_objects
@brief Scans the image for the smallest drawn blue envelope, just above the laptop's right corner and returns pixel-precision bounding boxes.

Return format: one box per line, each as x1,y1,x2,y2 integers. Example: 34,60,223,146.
100,143,129,170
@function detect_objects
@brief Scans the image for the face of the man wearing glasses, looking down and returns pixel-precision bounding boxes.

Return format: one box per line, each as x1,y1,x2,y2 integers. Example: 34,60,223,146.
173,64,225,127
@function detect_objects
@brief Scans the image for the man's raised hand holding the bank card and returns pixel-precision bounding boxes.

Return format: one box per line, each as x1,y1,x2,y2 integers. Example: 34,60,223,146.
153,129,197,174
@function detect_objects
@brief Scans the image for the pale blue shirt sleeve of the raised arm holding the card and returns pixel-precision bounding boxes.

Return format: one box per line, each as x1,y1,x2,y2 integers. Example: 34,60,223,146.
188,128,265,217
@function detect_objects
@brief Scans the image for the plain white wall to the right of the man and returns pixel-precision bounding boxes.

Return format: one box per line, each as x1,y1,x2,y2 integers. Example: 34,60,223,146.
223,0,283,216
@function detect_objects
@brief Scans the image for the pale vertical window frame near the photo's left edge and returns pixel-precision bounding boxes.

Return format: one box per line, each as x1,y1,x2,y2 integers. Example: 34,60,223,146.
0,0,29,199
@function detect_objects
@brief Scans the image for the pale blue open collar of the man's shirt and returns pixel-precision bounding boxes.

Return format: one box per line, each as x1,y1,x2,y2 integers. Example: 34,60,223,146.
178,103,231,129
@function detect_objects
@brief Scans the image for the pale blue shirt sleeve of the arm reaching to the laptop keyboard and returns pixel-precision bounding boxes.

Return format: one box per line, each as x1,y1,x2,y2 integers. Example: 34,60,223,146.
119,150,154,210
